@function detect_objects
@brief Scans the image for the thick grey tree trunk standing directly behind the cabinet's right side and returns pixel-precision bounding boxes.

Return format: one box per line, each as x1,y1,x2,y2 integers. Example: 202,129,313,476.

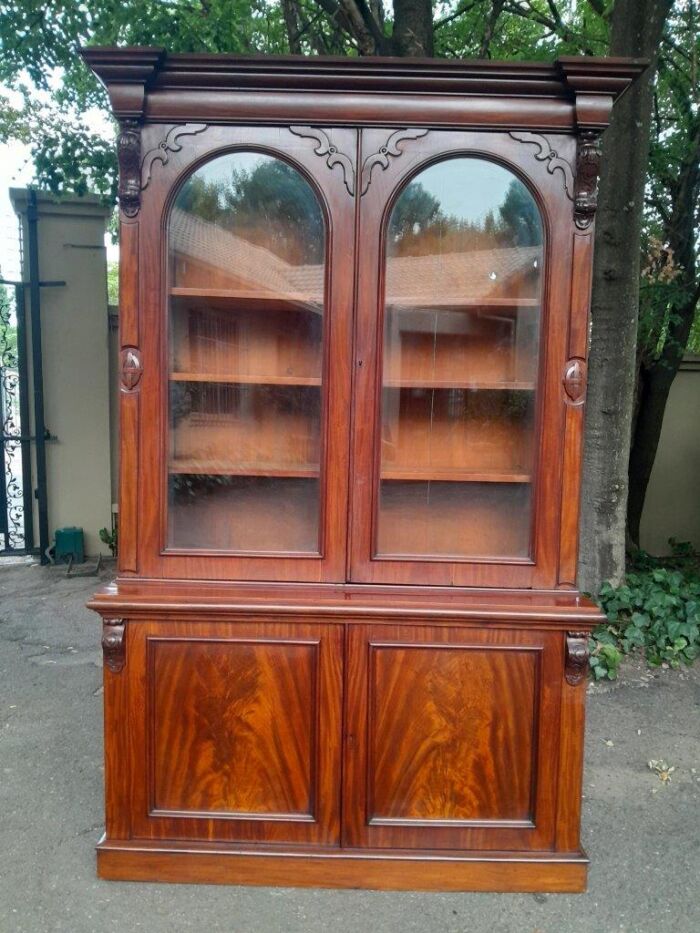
579,0,672,593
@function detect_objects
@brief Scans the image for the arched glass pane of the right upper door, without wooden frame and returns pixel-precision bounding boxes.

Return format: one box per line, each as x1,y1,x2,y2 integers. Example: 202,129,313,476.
376,158,542,558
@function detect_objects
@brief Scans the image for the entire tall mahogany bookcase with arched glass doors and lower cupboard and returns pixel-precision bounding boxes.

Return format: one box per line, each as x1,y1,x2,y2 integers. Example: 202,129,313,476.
84,49,640,891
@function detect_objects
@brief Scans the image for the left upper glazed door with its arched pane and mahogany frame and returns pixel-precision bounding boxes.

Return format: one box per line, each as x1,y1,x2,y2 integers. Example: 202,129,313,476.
133,124,356,581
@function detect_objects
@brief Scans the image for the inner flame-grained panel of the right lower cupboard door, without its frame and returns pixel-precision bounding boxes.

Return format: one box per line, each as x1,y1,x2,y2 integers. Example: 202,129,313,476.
369,644,540,825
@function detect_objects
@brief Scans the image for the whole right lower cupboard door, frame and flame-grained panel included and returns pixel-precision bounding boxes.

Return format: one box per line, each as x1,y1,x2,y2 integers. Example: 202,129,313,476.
344,626,562,849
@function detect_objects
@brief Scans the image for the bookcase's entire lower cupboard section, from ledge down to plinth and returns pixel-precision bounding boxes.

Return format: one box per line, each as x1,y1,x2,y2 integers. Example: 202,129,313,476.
92,590,596,892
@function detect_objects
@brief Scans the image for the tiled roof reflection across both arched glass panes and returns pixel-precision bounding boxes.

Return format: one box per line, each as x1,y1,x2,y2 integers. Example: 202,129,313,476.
170,208,542,304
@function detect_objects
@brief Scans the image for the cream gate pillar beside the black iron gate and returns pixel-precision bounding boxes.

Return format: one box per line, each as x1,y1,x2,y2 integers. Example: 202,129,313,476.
10,188,112,555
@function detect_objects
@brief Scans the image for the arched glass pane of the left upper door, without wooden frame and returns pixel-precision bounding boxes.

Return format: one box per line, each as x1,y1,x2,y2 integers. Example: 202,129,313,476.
168,152,325,553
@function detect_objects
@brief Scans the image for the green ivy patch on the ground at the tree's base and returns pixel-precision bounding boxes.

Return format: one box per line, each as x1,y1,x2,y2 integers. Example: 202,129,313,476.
590,539,700,680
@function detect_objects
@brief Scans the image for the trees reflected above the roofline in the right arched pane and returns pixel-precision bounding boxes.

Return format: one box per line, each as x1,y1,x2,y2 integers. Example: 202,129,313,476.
389,178,542,256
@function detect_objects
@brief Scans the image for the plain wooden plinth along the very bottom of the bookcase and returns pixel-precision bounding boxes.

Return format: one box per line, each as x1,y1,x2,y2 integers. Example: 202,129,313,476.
97,841,588,894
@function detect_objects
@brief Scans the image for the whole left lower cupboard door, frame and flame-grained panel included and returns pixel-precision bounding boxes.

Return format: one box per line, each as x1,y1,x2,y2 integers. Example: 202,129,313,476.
119,622,342,845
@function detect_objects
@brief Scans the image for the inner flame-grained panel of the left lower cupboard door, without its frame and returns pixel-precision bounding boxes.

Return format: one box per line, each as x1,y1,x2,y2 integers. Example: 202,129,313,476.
149,638,318,819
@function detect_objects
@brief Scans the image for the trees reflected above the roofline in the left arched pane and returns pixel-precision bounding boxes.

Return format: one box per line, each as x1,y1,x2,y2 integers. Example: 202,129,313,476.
177,155,325,265
